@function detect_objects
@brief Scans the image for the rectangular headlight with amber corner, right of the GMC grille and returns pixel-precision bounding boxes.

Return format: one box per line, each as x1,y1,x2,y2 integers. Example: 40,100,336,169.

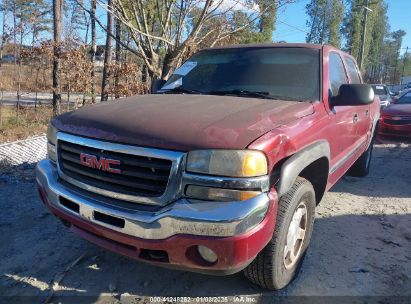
186,150,268,177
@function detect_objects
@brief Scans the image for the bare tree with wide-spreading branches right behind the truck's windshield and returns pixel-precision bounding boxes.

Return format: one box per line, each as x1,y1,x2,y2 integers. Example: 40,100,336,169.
76,0,293,84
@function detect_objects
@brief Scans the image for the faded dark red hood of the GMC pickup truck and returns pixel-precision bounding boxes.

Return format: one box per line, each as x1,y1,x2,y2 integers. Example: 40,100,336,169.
52,94,314,151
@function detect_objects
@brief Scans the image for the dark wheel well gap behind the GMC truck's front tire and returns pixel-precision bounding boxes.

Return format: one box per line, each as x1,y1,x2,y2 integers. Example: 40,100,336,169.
299,157,329,205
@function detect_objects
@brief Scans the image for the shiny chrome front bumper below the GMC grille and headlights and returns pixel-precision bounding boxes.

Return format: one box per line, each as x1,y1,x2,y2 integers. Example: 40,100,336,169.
36,160,271,240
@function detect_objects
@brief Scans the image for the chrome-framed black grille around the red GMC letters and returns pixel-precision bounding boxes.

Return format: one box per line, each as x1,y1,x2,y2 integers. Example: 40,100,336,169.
57,133,183,205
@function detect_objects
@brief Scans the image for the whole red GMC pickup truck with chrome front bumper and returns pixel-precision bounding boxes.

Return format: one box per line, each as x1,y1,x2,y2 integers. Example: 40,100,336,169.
36,44,380,289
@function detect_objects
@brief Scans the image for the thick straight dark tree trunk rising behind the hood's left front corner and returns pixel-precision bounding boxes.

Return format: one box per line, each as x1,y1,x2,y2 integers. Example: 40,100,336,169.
53,0,64,116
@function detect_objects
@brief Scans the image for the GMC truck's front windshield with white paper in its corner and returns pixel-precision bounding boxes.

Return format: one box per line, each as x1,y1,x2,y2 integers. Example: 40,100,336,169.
161,47,320,101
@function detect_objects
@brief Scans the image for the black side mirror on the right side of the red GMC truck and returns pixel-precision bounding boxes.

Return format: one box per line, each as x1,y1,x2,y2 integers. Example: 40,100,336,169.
330,84,375,106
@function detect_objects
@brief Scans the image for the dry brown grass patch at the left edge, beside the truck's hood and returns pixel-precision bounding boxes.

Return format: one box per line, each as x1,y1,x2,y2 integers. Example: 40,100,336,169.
0,106,52,144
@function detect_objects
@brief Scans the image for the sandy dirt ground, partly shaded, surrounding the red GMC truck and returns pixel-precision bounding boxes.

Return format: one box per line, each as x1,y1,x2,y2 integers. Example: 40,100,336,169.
0,138,411,303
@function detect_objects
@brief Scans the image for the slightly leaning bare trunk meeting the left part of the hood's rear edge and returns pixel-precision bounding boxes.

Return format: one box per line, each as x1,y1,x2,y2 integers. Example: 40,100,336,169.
101,0,114,101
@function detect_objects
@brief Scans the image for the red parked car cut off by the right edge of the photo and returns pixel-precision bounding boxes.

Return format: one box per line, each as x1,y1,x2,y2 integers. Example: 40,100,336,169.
379,92,411,137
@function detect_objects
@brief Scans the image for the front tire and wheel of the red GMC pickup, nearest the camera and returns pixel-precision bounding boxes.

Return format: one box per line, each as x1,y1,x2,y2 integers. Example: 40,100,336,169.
244,177,316,290
